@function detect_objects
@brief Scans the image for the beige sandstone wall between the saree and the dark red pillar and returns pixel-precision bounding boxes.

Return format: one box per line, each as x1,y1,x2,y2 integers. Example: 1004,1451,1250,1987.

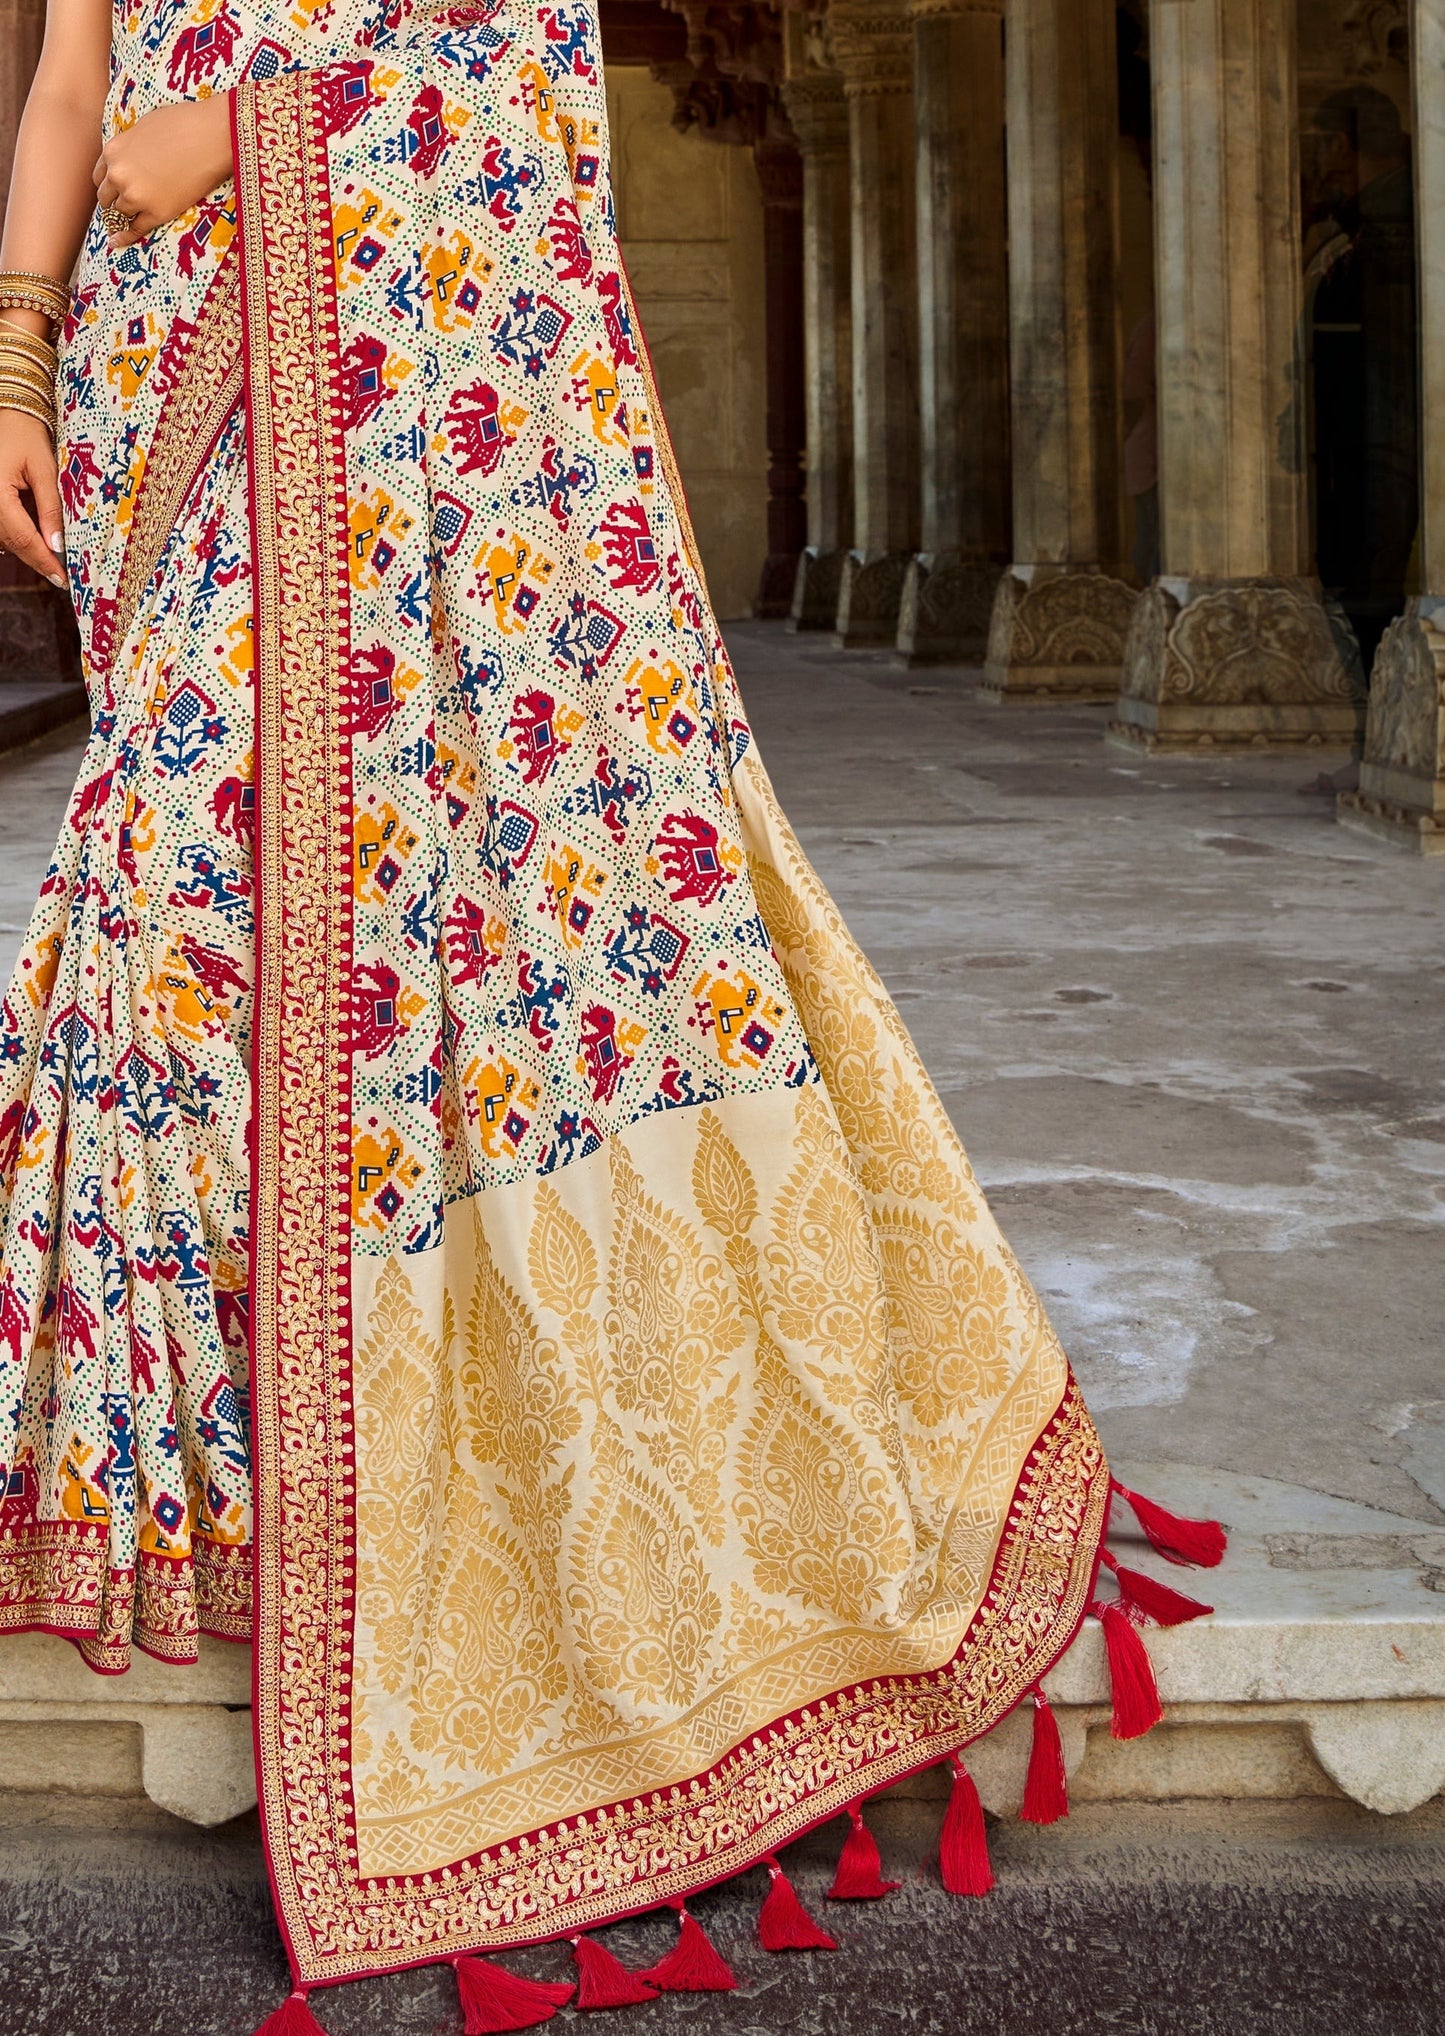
606,65,767,621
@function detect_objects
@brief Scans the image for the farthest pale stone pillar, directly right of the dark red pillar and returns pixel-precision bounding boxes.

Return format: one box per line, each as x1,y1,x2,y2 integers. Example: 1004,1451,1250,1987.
784,65,853,629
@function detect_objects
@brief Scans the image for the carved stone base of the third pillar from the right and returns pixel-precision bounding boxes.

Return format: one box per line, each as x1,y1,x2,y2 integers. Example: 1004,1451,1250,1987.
979,566,1138,700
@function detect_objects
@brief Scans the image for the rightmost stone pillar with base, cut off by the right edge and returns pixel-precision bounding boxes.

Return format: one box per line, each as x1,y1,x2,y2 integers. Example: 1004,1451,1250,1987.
1339,0,1445,855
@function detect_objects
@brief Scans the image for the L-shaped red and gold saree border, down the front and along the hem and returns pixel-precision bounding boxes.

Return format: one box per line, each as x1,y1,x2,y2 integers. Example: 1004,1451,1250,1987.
232,59,1109,1985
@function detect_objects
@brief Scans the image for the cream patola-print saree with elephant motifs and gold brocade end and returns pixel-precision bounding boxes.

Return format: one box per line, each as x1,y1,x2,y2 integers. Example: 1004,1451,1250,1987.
0,0,1221,2028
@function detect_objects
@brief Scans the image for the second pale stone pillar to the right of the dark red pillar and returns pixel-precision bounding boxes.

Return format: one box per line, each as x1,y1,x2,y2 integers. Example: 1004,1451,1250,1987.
826,0,918,645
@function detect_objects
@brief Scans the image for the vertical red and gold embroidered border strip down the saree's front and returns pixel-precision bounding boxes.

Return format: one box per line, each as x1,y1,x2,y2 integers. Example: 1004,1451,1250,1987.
232,71,354,1975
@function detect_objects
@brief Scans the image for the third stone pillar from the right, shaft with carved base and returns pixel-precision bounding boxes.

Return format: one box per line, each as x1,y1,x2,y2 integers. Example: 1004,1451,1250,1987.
983,0,1136,700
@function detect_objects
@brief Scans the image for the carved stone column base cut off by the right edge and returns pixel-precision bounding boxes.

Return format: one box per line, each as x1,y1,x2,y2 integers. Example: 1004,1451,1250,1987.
1335,595,1445,855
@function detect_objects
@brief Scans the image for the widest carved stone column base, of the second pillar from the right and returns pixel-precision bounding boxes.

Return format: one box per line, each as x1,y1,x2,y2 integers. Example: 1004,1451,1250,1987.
1107,580,1362,751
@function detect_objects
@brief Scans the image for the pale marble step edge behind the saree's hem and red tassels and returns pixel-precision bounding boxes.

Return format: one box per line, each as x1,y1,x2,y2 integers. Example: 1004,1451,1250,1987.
0,1462,1445,1853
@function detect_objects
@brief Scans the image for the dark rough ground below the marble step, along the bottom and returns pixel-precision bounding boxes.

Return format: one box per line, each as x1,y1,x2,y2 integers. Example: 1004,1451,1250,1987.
0,1806,1445,2036
